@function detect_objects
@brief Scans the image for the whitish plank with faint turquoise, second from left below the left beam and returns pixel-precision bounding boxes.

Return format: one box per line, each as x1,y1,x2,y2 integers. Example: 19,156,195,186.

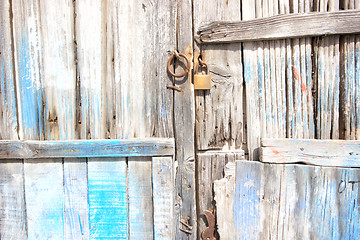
24,159,64,240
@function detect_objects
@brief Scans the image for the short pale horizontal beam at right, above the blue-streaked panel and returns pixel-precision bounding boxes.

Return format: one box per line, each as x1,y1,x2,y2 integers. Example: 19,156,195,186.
260,139,360,167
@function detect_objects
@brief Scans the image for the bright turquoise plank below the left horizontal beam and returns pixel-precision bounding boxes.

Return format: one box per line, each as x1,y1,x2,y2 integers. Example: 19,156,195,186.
88,158,129,239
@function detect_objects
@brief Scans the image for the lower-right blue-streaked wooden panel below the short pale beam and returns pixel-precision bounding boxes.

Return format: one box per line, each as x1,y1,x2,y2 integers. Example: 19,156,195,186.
234,161,359,239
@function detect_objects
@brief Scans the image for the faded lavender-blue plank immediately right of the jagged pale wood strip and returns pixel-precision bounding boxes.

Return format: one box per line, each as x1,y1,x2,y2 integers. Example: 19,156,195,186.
234,161,263,239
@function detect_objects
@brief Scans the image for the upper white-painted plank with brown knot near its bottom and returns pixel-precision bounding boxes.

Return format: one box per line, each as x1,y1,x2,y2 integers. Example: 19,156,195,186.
39,0,76,140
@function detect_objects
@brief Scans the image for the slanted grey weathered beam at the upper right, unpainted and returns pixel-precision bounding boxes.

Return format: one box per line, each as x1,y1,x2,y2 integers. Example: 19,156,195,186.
198,10,360,44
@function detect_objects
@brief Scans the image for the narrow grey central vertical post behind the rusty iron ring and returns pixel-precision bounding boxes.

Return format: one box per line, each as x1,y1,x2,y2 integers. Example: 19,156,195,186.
175,1,197,239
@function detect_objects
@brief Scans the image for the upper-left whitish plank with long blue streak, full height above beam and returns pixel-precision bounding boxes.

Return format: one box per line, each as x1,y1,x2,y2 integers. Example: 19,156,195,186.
12,0,44,139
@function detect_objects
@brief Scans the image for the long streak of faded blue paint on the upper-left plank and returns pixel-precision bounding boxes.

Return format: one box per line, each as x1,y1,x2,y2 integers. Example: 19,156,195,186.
17,34,43,139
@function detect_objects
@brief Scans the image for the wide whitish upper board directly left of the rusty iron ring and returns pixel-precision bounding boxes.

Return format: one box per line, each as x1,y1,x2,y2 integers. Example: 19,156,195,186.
104,0,176,139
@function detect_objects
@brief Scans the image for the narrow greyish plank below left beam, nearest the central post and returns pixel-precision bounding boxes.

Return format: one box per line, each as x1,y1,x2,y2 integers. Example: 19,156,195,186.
152,157,175,239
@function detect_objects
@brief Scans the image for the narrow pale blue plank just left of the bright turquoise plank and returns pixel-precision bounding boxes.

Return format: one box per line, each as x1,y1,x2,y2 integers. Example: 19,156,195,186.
64,158,89,240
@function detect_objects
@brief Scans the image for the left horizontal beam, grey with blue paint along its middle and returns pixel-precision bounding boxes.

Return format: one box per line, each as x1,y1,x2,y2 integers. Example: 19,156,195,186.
0,138,175,160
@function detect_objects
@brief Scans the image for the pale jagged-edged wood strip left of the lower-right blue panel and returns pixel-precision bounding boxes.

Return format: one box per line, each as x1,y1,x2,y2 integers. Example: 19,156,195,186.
214,162,236,239
